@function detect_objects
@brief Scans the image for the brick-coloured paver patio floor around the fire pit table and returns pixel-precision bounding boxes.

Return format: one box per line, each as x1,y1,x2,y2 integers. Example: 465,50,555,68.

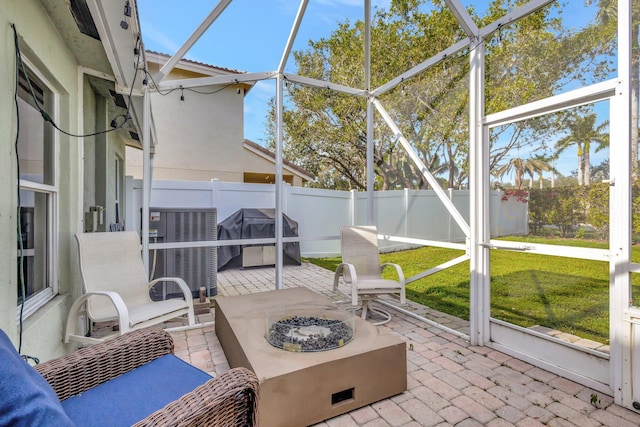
171,263,640,427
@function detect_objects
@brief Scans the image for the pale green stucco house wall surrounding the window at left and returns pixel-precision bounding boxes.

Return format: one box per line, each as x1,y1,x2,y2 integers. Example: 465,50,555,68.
0,0,93,360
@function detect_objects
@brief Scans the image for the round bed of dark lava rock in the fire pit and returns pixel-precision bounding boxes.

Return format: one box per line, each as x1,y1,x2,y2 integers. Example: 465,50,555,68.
266,316,353,352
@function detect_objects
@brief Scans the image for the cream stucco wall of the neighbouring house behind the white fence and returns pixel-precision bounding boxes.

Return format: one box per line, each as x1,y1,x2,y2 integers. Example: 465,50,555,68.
126,52,309,186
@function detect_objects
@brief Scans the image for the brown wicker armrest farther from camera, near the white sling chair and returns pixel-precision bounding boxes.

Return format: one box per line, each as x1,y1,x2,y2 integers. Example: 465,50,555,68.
35,328,173,400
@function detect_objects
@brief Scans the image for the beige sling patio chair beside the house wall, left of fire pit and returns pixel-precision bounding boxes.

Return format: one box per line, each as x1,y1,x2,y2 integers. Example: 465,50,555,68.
64,231,195,343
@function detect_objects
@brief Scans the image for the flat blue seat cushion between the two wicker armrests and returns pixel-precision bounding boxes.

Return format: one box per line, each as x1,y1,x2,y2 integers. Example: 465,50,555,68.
62,354,211,427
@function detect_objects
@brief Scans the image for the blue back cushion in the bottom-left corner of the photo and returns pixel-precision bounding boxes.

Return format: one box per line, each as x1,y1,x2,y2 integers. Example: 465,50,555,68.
0,330,73,427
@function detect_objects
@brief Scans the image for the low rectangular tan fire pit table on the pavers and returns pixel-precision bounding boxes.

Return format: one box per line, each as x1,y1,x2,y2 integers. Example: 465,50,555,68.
215,287,407,427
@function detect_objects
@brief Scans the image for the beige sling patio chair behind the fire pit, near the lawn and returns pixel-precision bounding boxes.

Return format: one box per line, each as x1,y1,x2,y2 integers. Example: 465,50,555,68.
333,226,406,325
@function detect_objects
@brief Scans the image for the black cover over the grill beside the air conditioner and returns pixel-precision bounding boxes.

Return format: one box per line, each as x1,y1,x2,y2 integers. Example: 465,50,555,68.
218,208,300,271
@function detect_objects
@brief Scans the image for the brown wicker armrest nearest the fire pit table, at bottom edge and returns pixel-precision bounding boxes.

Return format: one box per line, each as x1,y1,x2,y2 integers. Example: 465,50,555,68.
134,368,259,427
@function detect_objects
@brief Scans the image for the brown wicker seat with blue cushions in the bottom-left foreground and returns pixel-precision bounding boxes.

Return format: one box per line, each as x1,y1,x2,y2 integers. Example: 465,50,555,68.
0,328,258,426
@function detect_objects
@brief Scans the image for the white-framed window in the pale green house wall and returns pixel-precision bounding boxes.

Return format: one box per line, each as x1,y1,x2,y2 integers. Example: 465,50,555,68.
17,63,58,318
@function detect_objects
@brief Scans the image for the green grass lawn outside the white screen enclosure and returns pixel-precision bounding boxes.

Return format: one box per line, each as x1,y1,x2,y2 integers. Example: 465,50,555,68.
309,236,640,343
